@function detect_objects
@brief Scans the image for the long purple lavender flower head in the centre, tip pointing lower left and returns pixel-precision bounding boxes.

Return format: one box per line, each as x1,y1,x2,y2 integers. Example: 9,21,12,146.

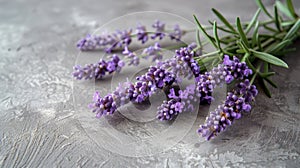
89,66,175,117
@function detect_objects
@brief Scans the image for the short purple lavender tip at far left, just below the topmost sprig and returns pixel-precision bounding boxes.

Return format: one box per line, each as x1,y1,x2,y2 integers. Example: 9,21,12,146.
73,54,124,80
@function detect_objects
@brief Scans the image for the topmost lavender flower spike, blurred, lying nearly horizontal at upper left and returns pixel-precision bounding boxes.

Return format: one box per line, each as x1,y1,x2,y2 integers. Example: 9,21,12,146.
77,20,185,53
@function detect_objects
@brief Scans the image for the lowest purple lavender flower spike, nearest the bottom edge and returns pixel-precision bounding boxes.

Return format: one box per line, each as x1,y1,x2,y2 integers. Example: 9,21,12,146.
198,79,258,140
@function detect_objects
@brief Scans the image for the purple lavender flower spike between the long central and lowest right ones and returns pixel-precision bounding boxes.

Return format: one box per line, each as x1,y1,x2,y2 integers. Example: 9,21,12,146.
157,56,252,120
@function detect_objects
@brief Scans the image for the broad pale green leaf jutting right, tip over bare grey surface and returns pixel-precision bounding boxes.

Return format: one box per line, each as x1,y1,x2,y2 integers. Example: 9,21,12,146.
250,49,289,68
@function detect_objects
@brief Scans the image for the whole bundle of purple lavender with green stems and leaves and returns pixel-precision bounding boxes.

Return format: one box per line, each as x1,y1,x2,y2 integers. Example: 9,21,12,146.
73,0,300,140
